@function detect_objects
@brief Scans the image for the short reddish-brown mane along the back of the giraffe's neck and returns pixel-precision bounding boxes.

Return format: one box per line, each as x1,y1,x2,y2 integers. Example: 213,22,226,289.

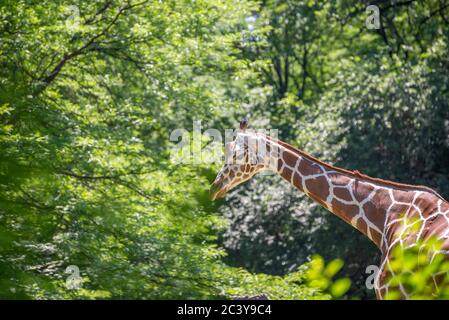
265,135,446,201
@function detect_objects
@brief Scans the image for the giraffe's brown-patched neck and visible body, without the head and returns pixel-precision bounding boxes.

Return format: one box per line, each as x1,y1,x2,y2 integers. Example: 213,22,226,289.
260,137,449,298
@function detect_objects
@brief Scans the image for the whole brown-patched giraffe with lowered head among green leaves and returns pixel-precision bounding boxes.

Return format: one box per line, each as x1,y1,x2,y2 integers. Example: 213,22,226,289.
210,120,449,299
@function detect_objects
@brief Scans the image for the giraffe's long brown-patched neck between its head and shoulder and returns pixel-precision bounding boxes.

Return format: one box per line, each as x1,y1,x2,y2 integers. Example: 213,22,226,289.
270,142,388,249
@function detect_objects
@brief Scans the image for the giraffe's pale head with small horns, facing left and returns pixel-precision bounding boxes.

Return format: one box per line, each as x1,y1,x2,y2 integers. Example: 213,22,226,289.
210,119,272,200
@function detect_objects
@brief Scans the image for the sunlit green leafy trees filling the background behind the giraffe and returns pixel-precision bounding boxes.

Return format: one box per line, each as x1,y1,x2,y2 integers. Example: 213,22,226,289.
0,0,449,299
